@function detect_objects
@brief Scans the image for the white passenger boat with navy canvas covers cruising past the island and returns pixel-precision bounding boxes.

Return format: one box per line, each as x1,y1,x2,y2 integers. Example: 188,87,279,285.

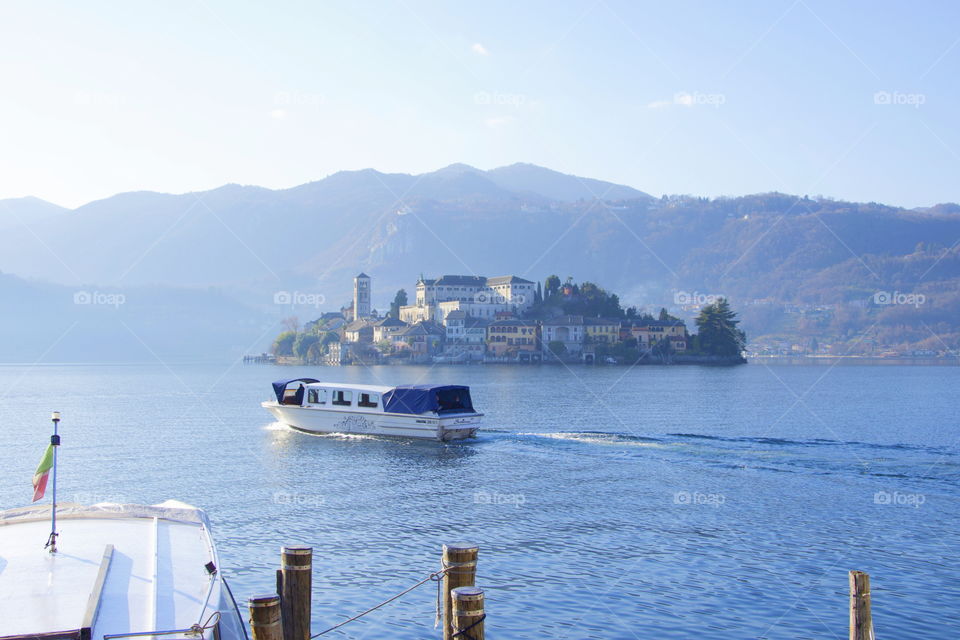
262,378,483,441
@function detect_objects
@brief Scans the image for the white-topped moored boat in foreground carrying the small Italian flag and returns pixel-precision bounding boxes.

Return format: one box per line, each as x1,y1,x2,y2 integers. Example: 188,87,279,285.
0,501,246,640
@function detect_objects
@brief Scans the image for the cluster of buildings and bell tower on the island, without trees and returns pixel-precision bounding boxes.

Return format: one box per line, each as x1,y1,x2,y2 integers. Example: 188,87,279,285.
308,273,689,364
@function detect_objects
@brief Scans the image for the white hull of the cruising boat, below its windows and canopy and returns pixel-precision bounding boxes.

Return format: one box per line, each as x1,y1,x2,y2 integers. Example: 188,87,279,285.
262,402,483,441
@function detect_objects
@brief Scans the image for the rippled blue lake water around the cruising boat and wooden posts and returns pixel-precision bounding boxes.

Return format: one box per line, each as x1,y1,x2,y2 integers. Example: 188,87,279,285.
0,365,960,640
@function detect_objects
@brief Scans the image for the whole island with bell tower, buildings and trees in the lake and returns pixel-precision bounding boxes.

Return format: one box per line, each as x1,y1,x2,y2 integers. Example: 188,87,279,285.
265,273,746,365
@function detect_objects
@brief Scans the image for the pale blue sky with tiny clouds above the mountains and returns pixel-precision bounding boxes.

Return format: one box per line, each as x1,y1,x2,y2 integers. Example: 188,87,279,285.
0,0,960,207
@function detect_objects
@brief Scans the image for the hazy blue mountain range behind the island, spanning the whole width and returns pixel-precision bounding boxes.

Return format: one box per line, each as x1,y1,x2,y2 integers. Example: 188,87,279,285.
0,164,960,361
